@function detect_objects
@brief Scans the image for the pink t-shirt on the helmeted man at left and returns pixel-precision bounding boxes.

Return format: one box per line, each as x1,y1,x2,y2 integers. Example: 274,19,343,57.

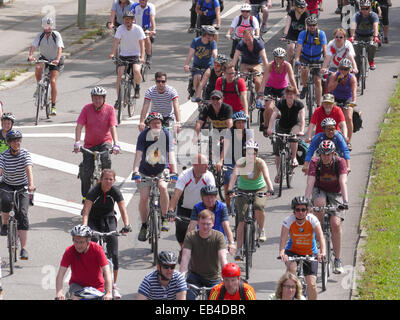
77,103,118,148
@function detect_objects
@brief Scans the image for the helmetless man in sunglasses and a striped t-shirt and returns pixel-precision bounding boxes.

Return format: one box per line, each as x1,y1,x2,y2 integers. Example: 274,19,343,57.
139,71,181,133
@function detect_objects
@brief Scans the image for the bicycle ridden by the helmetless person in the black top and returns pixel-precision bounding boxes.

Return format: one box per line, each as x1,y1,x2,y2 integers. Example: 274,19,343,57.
270,133,300,198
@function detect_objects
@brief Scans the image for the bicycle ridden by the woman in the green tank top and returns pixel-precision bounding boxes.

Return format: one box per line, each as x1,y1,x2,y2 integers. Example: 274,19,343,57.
233,191,268,280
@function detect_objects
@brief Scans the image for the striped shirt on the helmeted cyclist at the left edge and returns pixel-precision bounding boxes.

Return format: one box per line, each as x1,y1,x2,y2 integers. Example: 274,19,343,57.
0,148,33,186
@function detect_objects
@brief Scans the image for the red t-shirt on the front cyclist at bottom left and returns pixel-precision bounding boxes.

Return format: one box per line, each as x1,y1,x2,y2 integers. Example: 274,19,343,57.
60,241,108,292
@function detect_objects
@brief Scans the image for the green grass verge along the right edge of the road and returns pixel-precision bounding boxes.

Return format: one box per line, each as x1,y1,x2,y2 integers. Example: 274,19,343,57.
358,82,400,300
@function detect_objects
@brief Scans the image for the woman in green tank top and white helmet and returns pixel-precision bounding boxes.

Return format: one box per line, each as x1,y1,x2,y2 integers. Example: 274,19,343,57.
228,140,274,260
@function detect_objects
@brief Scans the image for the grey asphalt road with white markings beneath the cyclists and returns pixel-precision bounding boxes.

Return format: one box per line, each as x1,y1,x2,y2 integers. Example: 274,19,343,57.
0,1,400,300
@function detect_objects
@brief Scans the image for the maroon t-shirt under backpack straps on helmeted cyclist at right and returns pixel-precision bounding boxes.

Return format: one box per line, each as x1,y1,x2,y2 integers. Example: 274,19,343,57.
308,157,347,193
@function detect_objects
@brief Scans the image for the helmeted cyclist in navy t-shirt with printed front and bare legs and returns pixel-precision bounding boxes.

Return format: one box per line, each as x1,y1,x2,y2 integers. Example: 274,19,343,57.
132,112,177,241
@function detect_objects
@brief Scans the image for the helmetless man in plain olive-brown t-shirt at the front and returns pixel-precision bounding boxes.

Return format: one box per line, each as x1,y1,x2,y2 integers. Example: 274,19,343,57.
179,209,228,300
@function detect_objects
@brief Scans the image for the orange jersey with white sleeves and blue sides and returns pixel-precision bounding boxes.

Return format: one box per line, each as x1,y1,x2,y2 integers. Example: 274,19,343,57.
283,214,320,256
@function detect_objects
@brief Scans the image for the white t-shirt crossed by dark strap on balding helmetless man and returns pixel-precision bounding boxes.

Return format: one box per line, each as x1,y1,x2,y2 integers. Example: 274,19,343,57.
175,168,215,210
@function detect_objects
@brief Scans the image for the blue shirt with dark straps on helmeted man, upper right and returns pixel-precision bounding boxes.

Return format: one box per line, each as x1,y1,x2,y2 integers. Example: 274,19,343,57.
297,30,328,62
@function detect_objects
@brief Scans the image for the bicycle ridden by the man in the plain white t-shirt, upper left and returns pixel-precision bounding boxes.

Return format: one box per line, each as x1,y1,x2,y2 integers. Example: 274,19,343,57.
113,57,136,124
